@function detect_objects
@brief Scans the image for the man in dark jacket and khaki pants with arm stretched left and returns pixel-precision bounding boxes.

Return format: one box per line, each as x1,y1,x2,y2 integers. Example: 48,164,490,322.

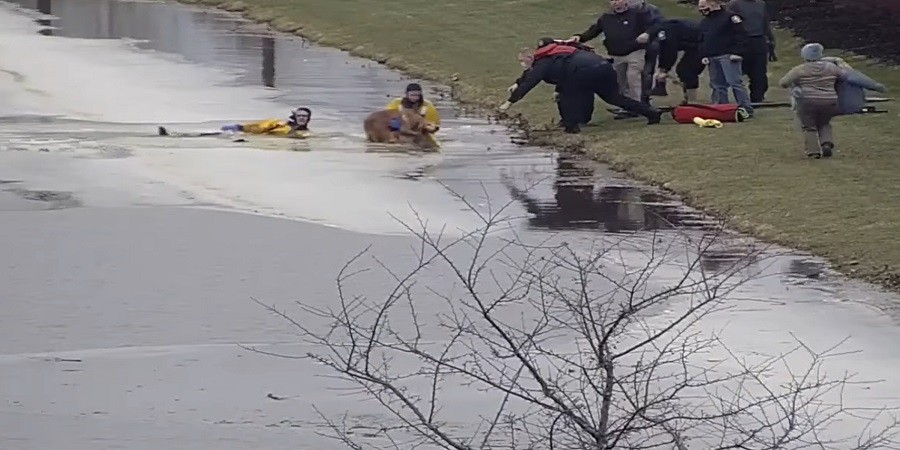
569,0,653,101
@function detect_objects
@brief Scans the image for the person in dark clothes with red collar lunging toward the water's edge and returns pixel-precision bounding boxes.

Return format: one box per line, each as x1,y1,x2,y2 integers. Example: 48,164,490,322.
500,38,662,133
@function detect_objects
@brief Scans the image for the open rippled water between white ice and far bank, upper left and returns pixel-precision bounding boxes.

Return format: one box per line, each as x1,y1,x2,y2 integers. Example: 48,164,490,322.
9,0,412,117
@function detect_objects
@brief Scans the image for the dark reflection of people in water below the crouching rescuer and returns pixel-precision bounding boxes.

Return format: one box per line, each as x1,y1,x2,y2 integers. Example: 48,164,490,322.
505,155,717,233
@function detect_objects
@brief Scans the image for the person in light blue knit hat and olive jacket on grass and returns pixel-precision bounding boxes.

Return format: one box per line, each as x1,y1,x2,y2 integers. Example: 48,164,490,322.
779,43,848,159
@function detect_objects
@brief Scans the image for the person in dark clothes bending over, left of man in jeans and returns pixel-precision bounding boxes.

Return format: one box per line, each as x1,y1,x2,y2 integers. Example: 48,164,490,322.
638,19,706,103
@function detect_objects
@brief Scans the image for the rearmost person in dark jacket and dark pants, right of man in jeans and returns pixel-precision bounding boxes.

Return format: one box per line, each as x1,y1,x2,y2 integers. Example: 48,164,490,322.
727,0,776,103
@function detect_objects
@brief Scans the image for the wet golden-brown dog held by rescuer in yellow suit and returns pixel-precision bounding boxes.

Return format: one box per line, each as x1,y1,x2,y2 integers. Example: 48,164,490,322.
363,109,439,150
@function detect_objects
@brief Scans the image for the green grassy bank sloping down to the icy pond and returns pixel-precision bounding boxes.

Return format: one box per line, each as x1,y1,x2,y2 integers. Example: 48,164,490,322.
190,0,900,288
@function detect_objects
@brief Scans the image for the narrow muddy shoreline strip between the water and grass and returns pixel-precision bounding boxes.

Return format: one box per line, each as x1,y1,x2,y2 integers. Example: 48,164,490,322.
176,0,900,292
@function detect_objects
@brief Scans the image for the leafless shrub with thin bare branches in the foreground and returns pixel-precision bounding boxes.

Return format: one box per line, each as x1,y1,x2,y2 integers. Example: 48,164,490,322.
248,185,897,450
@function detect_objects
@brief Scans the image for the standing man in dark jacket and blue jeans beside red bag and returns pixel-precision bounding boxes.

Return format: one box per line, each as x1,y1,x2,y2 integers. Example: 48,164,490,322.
697,0,753,116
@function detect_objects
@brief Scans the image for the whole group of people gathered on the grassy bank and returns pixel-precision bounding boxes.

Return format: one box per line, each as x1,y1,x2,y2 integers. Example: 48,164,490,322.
501,0,884,157
